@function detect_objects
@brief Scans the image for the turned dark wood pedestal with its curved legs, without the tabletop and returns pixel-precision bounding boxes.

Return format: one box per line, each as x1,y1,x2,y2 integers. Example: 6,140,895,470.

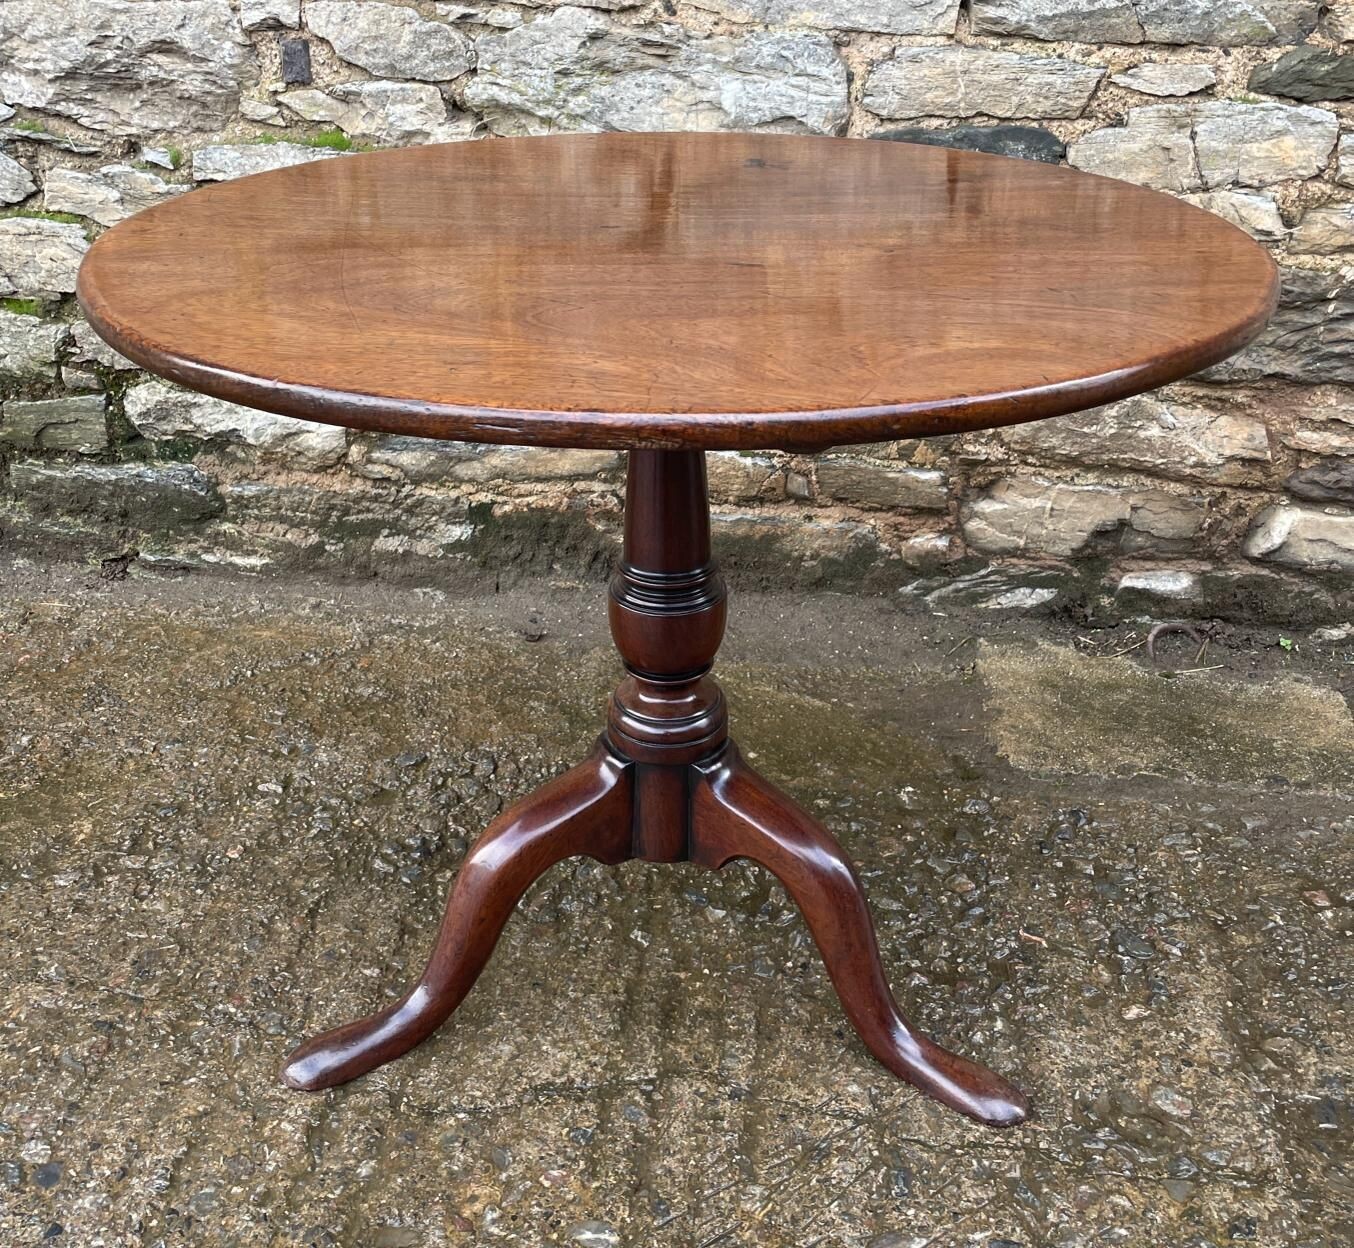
282,451,1029,1126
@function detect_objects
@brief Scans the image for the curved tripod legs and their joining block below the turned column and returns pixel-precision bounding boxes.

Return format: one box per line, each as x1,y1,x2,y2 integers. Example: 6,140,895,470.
282,742,1029,1126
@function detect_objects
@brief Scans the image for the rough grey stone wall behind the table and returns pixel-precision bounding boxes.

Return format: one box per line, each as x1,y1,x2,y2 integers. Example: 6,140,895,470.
0,0,1354,623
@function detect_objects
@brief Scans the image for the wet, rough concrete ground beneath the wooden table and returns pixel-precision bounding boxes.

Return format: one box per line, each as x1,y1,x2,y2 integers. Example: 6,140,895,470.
0,566,1354,1248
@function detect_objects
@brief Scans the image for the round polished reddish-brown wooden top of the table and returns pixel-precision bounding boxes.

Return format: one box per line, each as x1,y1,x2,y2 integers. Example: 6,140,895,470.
79,134,1277,449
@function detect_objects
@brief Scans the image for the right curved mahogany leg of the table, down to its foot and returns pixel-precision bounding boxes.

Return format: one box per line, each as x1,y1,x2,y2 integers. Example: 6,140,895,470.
691,744,1029,1126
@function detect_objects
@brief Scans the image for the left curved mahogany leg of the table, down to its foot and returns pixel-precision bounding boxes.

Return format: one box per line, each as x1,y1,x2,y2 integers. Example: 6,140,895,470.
282,743,631,1092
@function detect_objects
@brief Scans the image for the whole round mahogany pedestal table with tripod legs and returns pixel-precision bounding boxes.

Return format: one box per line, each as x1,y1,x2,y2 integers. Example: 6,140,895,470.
79,134,1277,1126
